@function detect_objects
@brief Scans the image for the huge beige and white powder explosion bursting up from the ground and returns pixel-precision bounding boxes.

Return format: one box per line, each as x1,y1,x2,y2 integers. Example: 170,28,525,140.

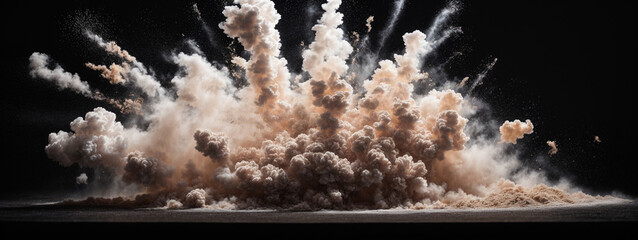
29,0,601,210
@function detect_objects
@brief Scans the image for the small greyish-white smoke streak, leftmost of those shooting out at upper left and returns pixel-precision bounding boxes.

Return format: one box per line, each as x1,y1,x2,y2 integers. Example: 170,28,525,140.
29,52,92,97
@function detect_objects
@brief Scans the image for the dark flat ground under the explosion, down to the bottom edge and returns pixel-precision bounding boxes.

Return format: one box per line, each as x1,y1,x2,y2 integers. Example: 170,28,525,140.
0,200,638,236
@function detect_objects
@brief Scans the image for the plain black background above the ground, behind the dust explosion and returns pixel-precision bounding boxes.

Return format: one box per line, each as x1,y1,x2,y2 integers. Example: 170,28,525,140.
0,1,638,197
